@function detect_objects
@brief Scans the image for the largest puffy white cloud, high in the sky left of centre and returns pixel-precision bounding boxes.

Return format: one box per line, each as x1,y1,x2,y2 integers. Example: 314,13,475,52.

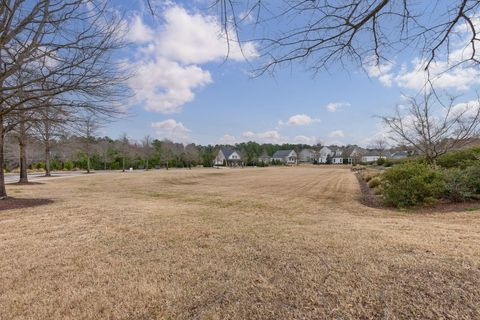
127,5,258,114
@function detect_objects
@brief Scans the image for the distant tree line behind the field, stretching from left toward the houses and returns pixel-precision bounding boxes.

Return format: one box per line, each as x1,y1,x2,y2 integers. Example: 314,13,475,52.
4,129,321,175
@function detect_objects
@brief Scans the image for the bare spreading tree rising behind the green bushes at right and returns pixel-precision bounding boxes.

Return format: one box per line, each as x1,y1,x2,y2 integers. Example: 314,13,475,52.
381,92,480,165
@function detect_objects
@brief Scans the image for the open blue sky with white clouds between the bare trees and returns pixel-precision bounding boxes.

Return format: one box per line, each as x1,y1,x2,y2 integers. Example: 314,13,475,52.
104,2,480,146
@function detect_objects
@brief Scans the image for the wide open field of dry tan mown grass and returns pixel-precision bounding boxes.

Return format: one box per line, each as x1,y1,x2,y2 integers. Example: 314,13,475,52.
0,167,480,319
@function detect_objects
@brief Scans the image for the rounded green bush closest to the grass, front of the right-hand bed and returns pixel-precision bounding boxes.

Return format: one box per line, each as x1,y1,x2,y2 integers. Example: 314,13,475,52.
382,162,445,208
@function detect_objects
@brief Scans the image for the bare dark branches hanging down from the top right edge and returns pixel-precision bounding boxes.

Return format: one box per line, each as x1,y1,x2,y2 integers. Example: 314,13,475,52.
208,0,480,74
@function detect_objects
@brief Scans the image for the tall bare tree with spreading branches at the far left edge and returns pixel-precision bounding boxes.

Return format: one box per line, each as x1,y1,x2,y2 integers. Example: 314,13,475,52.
0,0,130,199
